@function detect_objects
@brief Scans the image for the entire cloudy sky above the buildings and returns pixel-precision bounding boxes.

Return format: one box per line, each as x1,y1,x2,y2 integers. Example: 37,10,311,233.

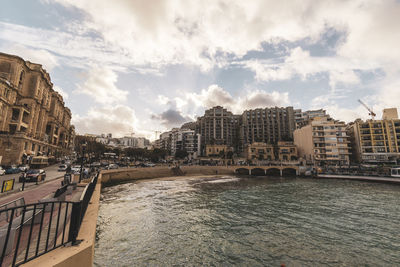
0,0,400,139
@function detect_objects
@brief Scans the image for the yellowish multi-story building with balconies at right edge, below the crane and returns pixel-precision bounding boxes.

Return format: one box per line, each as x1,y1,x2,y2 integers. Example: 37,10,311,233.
347,109,400,163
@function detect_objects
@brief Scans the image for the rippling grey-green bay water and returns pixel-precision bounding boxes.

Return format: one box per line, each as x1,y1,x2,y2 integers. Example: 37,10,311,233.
95,177,400,266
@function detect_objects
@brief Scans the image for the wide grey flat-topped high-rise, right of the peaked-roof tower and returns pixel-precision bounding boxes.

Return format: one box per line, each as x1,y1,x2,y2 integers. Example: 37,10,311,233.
242,107,295,147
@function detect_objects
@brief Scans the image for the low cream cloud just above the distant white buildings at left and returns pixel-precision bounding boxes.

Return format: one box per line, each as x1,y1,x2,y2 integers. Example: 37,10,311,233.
72,105,138,136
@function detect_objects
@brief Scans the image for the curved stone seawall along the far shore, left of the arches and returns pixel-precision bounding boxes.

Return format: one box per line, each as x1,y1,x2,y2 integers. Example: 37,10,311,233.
101,166,235,185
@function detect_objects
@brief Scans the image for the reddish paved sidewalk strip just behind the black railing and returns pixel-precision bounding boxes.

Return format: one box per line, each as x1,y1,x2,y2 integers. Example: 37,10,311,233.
0,178,64,205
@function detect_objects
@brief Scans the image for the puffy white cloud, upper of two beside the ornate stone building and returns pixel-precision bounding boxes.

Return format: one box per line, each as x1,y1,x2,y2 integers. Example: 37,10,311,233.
74,67,128,104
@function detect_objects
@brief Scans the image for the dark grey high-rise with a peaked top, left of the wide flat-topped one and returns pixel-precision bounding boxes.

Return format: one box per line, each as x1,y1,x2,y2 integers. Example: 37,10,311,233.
196,106,240,154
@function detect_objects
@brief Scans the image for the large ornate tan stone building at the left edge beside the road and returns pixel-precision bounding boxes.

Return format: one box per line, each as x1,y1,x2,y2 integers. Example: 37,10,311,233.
0,53,75,165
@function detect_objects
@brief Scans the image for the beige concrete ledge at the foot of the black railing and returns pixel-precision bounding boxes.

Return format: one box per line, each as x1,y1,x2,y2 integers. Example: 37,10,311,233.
21,174,101,267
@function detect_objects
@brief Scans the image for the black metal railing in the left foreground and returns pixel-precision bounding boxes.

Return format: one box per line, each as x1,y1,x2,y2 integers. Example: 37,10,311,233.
0,175,98,266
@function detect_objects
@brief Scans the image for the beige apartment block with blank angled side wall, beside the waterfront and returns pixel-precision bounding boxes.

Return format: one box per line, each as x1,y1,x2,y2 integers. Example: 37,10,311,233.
293,117,350,165
